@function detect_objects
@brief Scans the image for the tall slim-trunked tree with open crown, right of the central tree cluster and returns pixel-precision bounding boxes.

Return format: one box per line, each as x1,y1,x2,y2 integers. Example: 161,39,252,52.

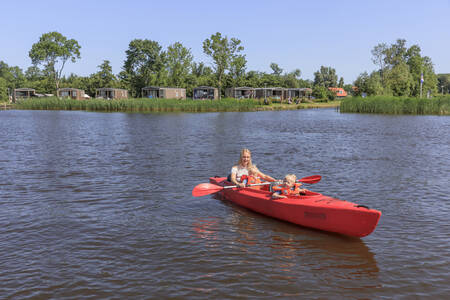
203,32,244,99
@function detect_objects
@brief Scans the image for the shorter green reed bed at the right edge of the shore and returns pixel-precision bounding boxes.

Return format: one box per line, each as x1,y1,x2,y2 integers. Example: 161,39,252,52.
340,96,450,115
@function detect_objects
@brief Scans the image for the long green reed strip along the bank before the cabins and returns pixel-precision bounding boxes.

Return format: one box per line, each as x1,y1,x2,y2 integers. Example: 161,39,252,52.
15,97,263,112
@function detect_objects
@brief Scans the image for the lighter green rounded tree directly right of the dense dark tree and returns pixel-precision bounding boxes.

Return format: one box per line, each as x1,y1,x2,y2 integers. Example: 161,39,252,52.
166,42,193,87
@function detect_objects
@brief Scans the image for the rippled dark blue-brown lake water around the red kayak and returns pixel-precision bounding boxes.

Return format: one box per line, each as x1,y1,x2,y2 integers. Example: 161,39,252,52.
0,109,450,299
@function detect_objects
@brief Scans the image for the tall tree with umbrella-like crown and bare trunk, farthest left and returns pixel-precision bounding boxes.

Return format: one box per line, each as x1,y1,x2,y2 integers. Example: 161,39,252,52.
28,31,81,89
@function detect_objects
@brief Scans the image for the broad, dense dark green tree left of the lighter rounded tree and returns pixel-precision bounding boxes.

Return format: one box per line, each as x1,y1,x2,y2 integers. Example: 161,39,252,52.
120,39,166,96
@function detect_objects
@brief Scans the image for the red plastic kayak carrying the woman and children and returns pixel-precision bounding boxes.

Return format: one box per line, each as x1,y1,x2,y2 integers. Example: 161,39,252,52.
209,177,381,237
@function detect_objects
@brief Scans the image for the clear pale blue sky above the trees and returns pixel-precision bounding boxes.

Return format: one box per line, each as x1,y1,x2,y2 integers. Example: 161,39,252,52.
0,0,450,83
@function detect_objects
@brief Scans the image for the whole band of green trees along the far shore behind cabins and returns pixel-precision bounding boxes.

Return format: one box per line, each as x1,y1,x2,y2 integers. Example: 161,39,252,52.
0,31,449,100
